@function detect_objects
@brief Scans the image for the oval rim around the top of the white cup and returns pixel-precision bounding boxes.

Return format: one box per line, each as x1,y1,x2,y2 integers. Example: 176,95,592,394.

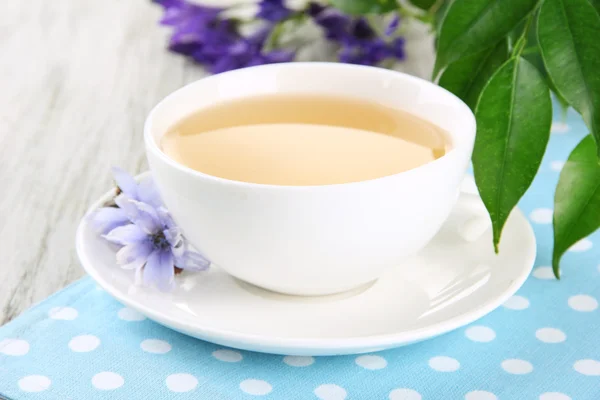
144,62,476,190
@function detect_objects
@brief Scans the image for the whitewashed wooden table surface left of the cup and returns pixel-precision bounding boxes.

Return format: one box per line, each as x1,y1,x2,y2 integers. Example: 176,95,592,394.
0,0,431,325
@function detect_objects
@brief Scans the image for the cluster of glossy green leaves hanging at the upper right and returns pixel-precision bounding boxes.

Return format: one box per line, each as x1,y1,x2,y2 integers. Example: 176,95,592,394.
331,0,600,277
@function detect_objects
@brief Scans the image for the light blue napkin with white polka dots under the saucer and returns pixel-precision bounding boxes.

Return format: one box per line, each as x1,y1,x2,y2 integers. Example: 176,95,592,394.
0,107,600,400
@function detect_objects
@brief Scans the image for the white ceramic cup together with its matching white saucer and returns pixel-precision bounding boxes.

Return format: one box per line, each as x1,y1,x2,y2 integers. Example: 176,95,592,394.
76,63,536,356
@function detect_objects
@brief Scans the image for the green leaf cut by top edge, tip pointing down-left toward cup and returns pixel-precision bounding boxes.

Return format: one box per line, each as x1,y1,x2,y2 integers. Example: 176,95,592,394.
433,0,538,77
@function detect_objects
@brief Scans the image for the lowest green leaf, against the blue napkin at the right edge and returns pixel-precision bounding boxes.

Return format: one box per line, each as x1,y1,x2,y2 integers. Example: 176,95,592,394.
552,135,600,278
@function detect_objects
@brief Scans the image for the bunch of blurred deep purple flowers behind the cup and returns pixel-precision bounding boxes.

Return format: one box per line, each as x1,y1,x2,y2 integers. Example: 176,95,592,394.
154,0,405,73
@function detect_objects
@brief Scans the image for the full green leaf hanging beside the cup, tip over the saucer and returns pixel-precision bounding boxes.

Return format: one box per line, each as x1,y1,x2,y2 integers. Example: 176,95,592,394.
473,57,552,251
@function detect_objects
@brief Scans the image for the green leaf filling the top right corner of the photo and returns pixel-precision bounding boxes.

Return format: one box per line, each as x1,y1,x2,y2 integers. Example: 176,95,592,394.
538,0,600,153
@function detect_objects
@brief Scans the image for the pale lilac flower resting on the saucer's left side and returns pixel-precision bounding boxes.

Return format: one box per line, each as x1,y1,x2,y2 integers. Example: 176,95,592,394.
91,168,210,290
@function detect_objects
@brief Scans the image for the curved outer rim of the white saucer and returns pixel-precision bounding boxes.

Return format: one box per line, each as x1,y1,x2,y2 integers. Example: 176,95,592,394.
76,172,537,356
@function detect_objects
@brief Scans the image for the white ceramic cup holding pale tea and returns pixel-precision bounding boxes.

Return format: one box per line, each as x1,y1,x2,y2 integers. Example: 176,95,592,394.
144,63,475,295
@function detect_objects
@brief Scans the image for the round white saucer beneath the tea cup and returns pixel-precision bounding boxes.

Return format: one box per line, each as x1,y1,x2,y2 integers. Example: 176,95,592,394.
77,181,536,355
